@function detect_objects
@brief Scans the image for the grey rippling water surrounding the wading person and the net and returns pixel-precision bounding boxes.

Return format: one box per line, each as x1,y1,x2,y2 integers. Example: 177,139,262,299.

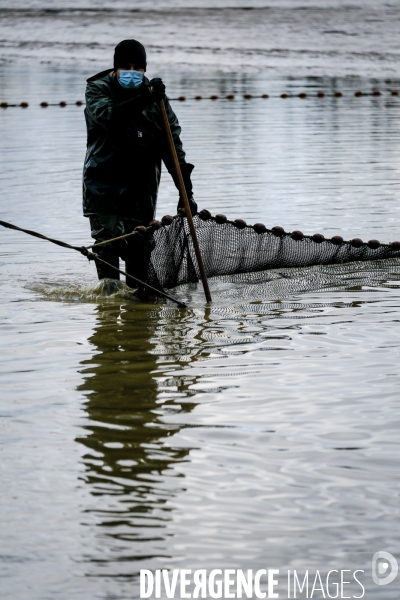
0,1,400,600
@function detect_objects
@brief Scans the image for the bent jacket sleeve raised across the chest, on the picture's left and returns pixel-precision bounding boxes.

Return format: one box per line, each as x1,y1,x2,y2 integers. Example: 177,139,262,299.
86,82,149,130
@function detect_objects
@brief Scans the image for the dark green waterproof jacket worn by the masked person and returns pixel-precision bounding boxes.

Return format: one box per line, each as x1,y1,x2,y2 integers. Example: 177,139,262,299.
83,70,185,225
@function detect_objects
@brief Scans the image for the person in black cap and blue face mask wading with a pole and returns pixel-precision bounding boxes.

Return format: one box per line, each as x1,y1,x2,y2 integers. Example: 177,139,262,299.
83,40,197,294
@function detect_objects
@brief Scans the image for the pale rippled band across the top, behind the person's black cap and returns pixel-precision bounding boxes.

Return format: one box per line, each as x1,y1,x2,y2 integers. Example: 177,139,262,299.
0,0,400,80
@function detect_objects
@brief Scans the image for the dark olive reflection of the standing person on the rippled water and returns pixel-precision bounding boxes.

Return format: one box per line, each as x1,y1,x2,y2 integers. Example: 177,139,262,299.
77,304,195,575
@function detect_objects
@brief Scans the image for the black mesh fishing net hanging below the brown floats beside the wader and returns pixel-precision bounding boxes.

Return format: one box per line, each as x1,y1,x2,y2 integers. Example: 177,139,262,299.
148,211,400,288
